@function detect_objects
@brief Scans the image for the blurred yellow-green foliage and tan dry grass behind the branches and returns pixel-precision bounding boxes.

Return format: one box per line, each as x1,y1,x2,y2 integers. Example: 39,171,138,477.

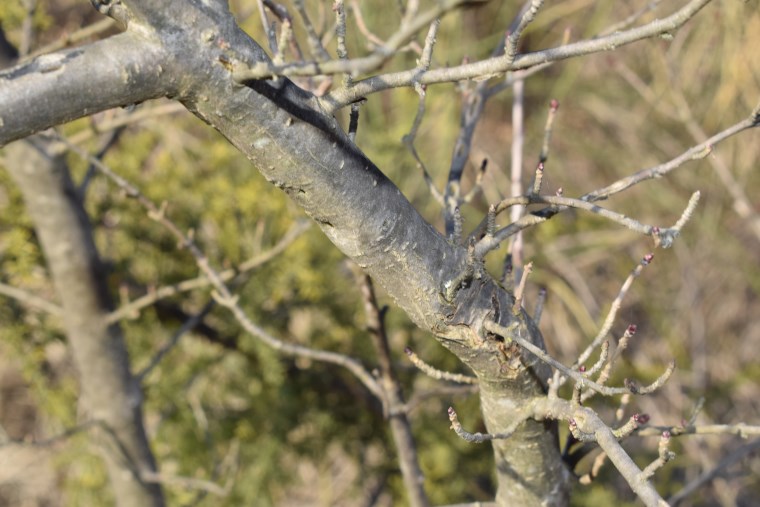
0,0,760,507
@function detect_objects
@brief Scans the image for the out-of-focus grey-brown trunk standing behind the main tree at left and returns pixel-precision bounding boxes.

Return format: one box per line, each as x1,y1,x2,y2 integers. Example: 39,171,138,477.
6,136,163,507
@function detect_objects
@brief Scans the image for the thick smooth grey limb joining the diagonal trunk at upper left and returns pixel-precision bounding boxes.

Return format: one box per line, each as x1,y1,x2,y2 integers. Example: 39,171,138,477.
0,32,173,146
